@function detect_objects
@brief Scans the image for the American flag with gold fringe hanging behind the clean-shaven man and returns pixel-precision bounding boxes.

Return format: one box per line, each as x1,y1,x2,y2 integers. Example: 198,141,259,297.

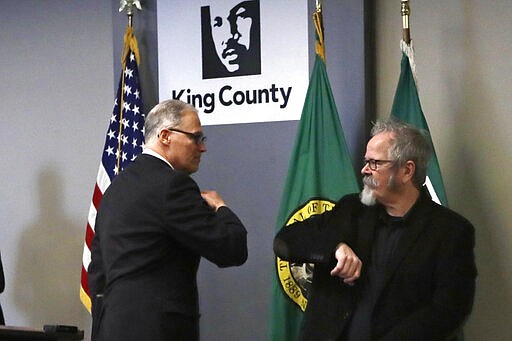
80,27,145,312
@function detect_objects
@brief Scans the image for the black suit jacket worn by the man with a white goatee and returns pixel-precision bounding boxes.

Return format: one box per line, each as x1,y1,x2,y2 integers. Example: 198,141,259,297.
274,192,476,341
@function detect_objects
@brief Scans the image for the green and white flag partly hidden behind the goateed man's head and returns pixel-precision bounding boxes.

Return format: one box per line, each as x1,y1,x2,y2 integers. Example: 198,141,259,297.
391,41,448,206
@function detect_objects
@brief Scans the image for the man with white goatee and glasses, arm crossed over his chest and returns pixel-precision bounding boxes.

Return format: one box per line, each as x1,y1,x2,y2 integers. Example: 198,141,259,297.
274,121,476,341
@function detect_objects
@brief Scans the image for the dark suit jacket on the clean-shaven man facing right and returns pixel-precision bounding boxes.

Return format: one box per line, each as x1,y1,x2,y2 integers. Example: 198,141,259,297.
89,154,247,341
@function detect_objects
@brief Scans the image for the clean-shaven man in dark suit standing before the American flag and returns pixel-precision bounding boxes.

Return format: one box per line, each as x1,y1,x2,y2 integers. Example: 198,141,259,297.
89,100,247,341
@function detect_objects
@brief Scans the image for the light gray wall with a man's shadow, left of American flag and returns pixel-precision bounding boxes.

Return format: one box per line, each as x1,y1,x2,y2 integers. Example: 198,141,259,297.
0,0,114,338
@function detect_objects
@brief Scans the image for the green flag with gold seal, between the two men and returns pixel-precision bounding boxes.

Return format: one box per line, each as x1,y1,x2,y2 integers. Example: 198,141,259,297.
271,5,359,341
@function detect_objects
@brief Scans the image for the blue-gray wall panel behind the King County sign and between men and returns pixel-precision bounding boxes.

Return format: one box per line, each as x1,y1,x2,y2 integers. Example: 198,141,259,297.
112,0,371,340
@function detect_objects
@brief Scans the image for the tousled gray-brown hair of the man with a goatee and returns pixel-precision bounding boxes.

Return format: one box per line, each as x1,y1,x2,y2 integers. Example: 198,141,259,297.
371,119,432,189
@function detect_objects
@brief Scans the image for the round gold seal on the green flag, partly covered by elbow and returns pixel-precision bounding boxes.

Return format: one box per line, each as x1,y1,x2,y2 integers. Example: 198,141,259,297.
276,198,335,311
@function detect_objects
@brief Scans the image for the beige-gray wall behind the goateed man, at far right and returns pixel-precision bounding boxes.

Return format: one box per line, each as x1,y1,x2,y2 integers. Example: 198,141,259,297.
375,0,512,341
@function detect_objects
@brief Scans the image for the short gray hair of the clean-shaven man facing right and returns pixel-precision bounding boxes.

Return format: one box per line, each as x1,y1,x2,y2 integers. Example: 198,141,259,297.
144,99,197,142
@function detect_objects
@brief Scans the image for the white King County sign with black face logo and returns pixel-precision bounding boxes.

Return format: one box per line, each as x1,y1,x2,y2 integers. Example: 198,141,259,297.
157,0,311,125
